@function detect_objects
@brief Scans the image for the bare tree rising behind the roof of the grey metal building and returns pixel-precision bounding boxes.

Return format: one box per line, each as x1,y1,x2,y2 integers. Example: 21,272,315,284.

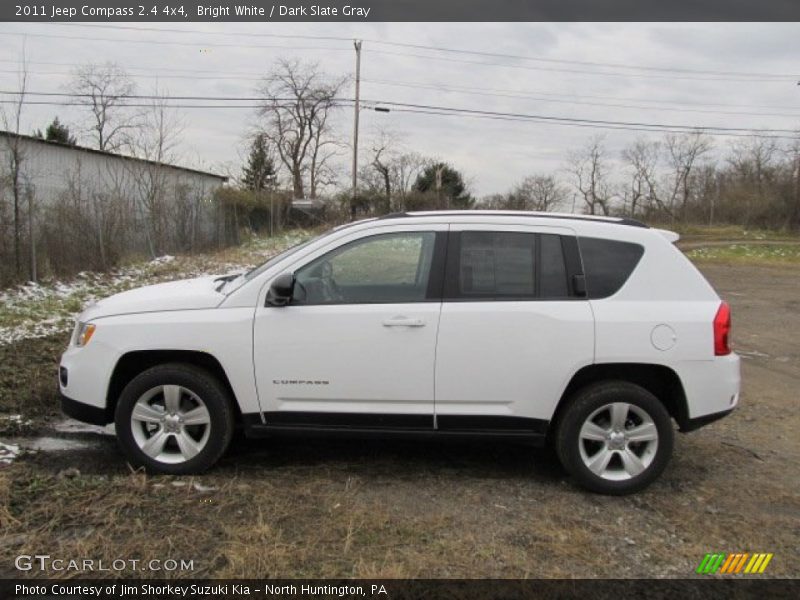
67,62,139,152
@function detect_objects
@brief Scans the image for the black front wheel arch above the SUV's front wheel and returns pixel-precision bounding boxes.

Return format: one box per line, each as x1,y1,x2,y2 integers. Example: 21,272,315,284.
106,350,242,424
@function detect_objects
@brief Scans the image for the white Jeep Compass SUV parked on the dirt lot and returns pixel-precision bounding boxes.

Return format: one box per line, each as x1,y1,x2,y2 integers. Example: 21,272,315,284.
59,211,740,494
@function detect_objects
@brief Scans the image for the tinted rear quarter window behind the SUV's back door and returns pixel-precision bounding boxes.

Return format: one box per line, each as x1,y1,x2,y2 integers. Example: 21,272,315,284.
578,237,644,299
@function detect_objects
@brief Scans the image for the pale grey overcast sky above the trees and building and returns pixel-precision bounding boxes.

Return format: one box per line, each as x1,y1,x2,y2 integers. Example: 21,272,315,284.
0,23,800,196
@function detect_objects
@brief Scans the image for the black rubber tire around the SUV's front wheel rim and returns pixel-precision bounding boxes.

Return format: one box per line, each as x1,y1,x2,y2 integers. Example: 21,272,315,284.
114,363,234,475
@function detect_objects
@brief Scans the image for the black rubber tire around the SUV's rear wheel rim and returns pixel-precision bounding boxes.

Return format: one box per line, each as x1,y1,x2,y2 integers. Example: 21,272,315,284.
555,381,675,495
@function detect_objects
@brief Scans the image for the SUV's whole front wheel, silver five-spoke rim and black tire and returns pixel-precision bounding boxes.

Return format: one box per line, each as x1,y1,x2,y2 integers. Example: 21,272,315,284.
114,363,234,475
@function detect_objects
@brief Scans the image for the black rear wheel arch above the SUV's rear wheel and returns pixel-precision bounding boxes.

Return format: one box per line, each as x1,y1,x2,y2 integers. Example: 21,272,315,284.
547,363,689,438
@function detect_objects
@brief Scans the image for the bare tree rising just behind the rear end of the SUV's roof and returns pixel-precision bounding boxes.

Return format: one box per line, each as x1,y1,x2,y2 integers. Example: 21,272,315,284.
567,136,613,215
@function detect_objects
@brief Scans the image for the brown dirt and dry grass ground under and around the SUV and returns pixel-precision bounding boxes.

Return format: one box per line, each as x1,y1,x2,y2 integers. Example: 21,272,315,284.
0,264,800,578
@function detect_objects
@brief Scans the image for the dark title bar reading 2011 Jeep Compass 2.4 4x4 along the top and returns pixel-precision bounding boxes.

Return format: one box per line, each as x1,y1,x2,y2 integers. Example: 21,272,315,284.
0,0,800,23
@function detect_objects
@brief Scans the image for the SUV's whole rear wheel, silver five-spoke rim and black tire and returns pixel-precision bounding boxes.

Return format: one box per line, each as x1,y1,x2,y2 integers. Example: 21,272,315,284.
556,381,674,494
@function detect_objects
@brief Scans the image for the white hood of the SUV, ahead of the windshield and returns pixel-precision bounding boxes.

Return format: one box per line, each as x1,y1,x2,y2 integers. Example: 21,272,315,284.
80,277,225,322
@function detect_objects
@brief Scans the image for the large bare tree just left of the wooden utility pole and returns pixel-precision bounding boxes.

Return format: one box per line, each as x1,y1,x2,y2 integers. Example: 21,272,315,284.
258,60,347,198
